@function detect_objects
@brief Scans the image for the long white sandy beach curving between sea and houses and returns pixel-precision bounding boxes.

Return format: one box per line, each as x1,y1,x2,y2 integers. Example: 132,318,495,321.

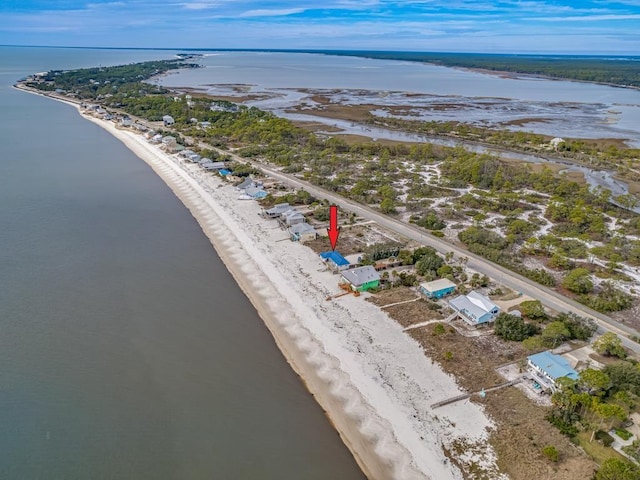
28,88,506,480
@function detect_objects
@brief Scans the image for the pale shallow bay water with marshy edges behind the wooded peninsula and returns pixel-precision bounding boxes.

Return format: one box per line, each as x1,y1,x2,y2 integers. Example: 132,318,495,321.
159,52,640,147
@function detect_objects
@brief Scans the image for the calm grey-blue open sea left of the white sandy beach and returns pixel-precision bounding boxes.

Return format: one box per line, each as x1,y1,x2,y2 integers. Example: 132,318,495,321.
0,47,363,480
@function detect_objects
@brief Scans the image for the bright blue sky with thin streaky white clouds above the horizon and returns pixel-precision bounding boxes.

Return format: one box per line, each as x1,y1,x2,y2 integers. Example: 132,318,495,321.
0,0,640,54
